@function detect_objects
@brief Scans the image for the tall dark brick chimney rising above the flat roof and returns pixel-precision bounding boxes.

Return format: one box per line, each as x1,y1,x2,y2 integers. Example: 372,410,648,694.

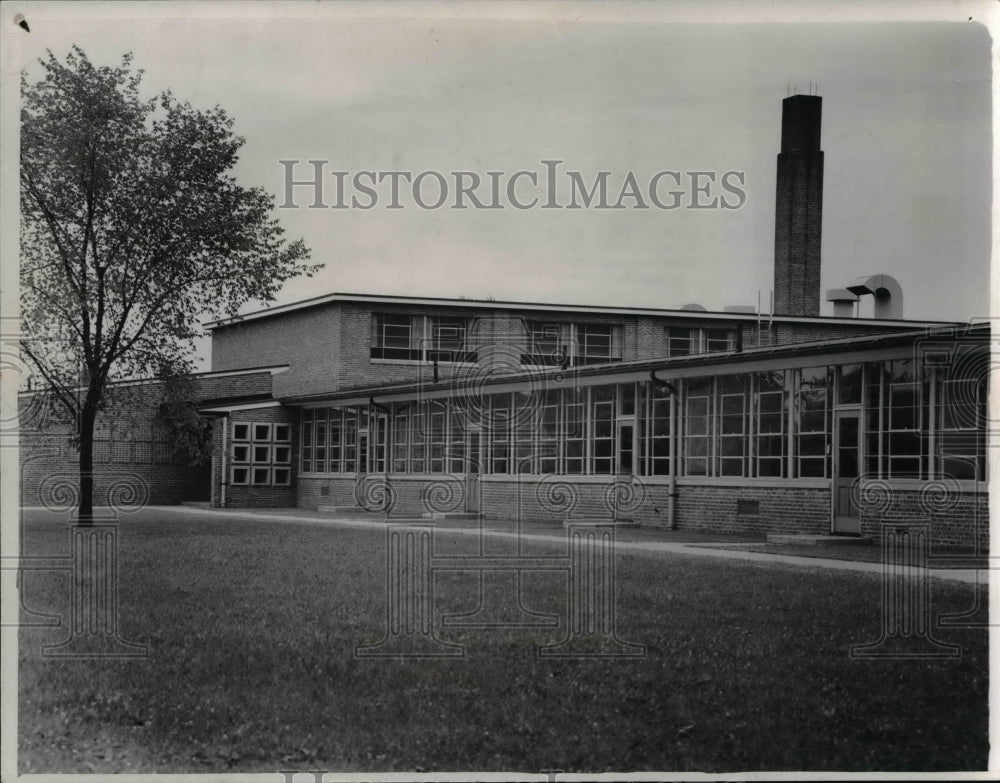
774,95,823,316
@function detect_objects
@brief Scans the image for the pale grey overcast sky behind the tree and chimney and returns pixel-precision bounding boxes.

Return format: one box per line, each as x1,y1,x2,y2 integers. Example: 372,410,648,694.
4,3,991,370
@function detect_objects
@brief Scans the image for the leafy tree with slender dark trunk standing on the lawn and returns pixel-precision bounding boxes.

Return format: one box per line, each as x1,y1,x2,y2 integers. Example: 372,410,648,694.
20,47,318,521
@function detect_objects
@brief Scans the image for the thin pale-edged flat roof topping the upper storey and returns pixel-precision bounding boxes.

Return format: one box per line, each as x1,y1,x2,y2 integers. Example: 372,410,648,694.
202,293,958,330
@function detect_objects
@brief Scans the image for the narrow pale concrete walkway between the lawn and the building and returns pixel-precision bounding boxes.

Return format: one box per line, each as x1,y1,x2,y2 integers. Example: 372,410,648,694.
150,506,989,586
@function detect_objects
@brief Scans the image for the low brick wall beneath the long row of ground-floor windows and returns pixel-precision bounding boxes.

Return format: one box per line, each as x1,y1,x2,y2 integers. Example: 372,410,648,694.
296,474,989,547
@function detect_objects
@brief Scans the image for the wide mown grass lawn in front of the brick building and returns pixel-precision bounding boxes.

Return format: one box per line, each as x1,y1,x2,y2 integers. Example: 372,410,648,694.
19,510,988,773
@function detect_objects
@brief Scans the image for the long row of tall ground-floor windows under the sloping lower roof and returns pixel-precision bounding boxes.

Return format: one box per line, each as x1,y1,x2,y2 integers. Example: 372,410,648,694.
300,360,986,479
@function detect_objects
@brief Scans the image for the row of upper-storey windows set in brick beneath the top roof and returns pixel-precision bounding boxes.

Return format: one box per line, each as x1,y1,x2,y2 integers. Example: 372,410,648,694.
371,313,736,366
